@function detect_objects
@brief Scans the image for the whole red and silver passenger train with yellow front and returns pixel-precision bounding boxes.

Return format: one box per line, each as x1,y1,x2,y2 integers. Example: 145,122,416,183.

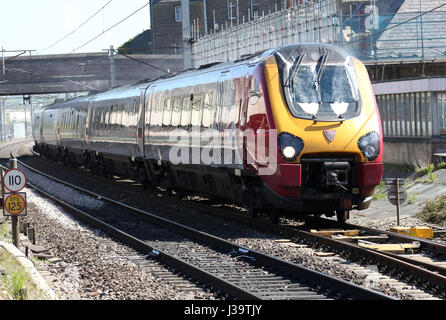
33,43,383,221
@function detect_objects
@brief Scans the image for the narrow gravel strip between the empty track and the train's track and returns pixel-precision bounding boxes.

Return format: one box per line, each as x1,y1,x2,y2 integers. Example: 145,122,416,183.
11,141,442,299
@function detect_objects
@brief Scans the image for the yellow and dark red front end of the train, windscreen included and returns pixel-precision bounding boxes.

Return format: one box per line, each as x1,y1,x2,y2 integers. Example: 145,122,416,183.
262,44,383,221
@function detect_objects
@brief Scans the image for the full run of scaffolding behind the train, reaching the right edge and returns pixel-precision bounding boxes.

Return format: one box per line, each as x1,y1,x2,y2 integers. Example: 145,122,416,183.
192,0,446,67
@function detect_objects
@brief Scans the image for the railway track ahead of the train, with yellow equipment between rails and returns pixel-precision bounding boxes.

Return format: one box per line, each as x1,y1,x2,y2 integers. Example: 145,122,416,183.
177,202,446,298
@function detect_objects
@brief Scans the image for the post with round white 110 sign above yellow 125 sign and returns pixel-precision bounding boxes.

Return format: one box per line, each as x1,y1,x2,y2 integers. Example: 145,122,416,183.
2,159,26,248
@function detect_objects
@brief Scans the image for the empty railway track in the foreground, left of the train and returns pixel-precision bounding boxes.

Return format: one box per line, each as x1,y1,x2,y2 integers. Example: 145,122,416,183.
3,146,392,300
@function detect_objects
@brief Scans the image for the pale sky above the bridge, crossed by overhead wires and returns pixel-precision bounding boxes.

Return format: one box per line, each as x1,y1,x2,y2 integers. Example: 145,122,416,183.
0,0,150,56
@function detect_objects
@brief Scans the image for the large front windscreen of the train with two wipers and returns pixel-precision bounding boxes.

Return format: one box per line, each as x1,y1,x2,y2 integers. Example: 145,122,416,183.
279,44,361,121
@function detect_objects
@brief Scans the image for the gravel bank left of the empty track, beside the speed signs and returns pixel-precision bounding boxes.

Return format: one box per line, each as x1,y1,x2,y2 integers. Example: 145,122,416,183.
17,189,215,300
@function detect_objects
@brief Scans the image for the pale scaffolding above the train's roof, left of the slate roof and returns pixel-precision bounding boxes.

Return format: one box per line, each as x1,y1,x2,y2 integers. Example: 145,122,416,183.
192,0,340,67
